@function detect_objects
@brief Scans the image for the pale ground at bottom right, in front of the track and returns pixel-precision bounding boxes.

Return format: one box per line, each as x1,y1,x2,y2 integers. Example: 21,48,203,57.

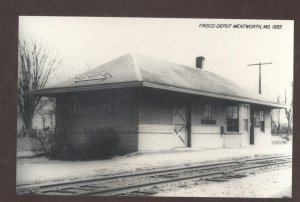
156,167,292,198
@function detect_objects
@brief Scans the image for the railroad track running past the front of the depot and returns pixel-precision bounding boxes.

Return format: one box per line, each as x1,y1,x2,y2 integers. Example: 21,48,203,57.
17,155,292,196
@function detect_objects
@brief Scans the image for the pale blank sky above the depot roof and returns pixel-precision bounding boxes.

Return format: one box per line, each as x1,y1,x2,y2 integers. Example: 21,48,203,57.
19,16,294,102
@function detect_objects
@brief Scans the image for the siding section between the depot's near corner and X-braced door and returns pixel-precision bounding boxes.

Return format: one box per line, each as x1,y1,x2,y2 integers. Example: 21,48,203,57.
138,89,188,150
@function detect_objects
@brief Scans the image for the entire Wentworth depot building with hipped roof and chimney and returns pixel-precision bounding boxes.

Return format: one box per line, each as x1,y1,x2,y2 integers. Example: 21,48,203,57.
31,54,283,153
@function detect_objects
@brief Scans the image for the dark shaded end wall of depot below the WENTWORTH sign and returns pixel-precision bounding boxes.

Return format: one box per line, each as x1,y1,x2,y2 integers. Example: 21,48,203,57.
56,90,138,153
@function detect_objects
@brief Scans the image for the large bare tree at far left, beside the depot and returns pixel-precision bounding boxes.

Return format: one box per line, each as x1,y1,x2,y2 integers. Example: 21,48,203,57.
18,39,61,137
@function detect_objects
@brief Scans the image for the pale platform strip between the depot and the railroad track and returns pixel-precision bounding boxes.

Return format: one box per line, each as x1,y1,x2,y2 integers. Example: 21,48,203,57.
16,144,292,185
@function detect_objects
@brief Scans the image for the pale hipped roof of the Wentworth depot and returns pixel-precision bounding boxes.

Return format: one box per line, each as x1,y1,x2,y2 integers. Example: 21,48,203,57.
31,54,283,108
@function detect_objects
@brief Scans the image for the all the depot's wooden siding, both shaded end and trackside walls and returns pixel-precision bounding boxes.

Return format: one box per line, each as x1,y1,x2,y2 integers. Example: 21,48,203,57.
56,89,271,153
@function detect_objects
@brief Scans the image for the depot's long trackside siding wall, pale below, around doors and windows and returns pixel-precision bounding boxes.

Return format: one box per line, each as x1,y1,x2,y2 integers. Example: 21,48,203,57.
138,92,271,150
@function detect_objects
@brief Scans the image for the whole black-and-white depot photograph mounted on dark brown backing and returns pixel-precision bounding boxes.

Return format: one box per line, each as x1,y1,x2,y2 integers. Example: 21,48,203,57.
16,16,294,198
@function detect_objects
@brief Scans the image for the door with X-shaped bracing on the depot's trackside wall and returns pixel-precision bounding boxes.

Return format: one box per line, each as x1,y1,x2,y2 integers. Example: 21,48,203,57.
173,105,188,146
